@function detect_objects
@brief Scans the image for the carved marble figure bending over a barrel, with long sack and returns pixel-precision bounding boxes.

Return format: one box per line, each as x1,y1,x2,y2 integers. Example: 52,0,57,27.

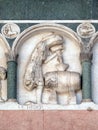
24,33,80,104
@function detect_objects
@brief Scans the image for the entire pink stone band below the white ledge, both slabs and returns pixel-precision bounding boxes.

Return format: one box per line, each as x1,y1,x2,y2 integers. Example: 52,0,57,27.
0,111,98,130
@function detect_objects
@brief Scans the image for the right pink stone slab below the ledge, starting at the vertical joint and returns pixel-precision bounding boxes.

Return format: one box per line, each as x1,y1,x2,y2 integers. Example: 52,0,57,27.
44,111,98,130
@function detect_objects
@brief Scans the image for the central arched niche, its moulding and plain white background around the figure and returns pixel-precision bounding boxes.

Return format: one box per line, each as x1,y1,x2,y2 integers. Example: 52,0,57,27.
12,24,81,104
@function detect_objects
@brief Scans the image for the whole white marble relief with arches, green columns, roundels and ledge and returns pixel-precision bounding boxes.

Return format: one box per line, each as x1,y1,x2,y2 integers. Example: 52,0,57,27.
0,22,98,110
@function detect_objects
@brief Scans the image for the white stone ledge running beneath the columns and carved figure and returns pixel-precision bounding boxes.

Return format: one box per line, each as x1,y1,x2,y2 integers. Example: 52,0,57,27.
0,101,98,111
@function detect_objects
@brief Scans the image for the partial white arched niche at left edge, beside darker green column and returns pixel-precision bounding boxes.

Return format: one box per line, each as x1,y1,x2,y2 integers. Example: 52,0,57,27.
0,34,10,102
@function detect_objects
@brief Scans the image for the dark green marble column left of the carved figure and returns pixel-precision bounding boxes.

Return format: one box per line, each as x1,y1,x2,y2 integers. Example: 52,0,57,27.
7,53,17,101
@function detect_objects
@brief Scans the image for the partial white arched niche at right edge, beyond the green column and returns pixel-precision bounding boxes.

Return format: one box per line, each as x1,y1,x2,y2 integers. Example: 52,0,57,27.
90,32,98,104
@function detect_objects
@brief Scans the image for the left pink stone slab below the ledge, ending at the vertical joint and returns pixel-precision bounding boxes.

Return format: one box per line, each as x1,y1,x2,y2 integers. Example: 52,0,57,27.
0,111,43,130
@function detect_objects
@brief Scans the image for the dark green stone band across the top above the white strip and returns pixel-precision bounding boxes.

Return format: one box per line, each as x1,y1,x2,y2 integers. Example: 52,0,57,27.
0,0,98,20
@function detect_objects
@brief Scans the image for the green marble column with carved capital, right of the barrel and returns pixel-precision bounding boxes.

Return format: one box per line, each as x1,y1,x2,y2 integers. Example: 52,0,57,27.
80,52,92,102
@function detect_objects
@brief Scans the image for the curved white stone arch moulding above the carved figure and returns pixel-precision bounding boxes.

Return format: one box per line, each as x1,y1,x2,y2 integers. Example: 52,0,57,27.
12,24,82,55
